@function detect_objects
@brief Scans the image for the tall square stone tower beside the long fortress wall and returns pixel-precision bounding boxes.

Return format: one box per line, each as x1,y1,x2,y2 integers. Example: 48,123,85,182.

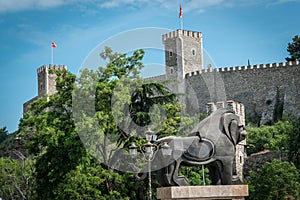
162,30,203,79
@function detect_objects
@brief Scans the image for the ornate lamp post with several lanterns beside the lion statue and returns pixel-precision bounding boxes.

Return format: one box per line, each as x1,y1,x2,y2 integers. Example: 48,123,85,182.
129,130,172,200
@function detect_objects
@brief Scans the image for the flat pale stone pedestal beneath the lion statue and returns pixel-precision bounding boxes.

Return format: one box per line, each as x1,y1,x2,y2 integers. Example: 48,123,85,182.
157,185,249,200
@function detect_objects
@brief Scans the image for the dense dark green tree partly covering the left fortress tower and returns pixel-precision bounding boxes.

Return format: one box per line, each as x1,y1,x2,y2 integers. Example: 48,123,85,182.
19,69,86,199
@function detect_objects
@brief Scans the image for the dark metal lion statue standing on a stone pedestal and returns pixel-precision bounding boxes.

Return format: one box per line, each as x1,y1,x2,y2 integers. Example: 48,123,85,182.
150,109,246,186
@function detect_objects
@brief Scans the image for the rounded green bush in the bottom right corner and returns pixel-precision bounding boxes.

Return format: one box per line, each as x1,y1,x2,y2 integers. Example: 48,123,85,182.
249,160,300,200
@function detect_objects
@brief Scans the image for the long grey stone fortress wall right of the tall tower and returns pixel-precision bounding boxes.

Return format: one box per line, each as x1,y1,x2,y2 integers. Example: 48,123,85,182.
185,61,300,124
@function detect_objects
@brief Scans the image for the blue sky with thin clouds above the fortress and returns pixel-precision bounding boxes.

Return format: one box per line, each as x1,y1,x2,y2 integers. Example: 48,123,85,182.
0,0,300,133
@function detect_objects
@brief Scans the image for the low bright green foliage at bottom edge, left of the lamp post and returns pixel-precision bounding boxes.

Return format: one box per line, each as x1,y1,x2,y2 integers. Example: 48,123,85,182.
57,157,144,200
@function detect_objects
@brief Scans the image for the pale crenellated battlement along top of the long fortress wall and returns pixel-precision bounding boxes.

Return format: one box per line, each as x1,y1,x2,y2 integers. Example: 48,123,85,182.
185,61,300,77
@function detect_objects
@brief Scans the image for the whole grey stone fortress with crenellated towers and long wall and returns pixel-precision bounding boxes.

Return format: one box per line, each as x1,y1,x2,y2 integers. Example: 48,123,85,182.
23,30,300,183
